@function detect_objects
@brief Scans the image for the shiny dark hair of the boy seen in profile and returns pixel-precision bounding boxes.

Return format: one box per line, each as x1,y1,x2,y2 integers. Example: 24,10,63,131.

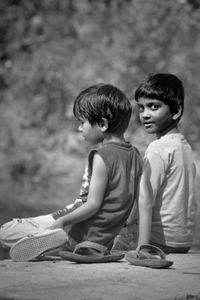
73,83,132,133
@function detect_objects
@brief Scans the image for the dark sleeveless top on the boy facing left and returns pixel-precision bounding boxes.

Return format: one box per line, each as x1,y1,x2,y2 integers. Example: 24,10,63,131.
69,142,142,249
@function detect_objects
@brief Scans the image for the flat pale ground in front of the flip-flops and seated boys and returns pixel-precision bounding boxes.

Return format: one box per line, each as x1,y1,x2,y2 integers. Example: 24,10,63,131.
0,250,200,300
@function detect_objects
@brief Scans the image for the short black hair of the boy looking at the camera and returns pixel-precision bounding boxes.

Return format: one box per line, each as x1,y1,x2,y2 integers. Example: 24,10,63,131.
135,73,184,121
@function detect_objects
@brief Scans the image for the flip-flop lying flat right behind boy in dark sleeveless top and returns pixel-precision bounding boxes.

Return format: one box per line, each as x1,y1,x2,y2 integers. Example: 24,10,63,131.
59,241,124,263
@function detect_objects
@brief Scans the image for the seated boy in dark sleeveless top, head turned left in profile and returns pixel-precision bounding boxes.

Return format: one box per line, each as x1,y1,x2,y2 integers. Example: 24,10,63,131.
10,84,142,261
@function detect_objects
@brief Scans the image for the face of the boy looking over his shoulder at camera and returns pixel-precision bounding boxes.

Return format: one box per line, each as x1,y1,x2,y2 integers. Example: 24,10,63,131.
137,98,175,137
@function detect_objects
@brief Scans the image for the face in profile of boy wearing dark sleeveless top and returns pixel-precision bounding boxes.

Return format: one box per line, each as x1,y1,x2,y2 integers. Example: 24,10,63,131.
78,120,104,145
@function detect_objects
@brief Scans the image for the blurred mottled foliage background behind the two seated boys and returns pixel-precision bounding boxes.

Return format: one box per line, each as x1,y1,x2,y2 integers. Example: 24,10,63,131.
0,0,200,247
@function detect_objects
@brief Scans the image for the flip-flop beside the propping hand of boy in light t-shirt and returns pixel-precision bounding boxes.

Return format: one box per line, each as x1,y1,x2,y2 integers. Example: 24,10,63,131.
125,245,173,269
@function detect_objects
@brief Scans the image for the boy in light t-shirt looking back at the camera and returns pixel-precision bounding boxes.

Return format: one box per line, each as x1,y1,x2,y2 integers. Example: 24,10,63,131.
128,74,196,256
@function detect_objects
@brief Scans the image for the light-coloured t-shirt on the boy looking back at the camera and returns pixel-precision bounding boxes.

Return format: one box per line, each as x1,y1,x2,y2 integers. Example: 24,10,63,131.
140,133,196,247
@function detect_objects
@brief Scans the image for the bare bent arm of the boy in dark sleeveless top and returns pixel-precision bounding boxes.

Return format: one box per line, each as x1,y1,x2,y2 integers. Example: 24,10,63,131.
48,153,108,229
